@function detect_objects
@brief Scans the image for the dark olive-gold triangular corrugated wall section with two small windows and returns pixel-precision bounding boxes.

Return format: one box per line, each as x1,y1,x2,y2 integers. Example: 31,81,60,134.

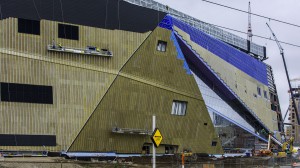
69,28,222,153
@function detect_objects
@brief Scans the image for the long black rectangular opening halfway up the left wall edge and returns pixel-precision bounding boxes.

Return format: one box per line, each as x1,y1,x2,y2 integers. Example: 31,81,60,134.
1,83,53,104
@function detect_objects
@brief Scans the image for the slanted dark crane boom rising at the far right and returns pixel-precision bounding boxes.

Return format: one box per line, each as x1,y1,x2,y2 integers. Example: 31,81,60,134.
266,23,300,125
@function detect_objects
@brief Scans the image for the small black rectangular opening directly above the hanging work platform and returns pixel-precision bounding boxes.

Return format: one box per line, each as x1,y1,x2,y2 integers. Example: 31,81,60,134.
58,24,79,40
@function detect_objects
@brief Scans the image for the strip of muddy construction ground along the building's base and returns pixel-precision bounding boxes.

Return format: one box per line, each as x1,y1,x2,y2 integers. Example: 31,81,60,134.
0,157,300,168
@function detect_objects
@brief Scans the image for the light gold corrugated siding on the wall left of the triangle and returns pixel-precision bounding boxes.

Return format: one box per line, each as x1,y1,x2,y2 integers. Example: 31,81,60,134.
0,18,149,151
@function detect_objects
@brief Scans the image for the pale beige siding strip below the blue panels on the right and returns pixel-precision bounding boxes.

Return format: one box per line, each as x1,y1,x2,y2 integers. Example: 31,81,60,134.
175,27,278,131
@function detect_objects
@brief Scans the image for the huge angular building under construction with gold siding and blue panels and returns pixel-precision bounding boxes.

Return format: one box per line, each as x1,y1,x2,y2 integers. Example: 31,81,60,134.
0,0,283,154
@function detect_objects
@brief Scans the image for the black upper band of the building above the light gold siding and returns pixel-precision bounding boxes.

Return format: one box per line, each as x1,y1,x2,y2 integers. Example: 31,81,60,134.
0,0,166,32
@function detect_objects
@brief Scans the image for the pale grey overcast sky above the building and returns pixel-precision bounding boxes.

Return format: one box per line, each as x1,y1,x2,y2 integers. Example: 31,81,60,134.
156,0,300,118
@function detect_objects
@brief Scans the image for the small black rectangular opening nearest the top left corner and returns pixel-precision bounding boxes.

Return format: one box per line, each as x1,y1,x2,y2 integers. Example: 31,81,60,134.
18,18,40,35
